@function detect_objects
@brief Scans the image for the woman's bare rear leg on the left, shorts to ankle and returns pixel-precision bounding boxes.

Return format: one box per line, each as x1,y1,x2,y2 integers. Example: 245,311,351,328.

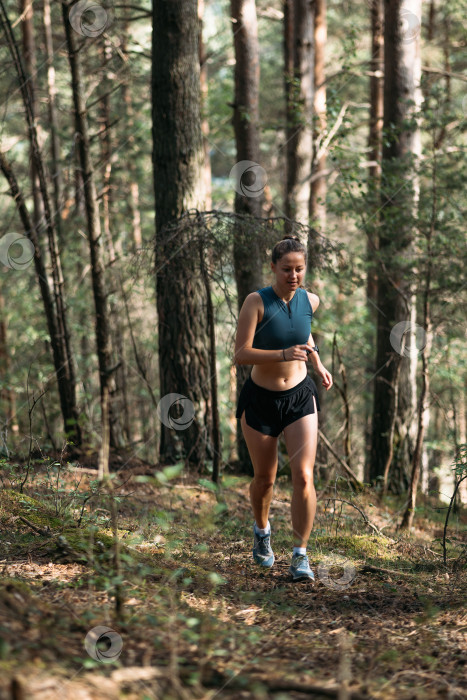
240,411,279,528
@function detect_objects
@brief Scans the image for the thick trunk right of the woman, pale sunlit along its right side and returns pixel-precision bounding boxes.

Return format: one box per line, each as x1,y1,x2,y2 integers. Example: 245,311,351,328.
369,0,421,493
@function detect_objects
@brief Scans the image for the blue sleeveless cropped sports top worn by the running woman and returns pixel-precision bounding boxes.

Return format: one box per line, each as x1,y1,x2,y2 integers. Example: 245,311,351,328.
253,285,313,350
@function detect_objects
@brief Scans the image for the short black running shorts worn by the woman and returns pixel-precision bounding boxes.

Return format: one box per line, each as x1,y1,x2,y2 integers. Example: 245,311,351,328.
235,375,321,437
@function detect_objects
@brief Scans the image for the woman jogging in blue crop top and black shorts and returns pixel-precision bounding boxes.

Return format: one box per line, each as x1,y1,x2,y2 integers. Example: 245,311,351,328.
235,236,332,581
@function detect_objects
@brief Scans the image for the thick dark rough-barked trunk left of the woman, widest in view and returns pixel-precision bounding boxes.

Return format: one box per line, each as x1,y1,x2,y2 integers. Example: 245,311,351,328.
152,0,212,467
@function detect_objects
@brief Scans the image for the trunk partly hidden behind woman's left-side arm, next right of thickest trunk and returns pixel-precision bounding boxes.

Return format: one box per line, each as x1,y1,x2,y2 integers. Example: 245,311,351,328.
230,0,265,473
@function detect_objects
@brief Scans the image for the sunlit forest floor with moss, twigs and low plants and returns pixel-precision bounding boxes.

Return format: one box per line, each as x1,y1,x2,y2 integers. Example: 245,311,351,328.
0,452,467,700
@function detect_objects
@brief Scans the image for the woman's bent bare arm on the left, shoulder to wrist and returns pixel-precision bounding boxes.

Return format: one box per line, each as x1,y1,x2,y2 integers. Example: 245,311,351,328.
234,292,284,365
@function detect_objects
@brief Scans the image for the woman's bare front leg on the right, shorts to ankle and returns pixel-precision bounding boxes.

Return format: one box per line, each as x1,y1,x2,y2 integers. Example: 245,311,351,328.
284,397,318,547
